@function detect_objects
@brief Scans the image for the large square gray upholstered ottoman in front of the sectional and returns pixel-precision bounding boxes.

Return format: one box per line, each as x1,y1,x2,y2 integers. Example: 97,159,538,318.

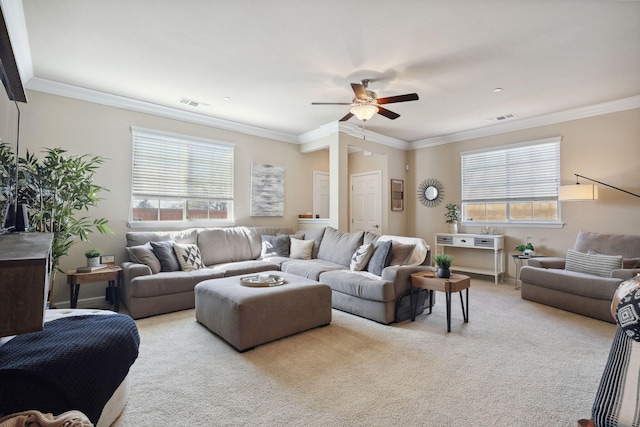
195,271,331,351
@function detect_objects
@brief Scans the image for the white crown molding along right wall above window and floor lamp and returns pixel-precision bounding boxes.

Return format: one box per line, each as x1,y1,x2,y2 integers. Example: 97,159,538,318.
411,95,640,149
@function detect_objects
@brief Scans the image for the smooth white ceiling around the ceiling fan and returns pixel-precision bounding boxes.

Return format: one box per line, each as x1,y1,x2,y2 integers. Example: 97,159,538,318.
3,0,640,142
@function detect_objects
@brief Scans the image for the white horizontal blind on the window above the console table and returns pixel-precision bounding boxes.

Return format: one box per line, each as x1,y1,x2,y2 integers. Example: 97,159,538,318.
461,138,560,203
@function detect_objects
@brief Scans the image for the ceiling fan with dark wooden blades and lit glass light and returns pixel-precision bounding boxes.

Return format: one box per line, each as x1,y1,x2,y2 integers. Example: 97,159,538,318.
311,79,419,122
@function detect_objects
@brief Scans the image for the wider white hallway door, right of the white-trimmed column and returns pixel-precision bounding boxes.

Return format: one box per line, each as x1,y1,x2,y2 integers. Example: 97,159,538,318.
351,171,382,234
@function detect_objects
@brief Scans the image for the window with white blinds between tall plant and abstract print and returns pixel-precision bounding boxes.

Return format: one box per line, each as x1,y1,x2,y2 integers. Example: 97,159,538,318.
130,127,235,225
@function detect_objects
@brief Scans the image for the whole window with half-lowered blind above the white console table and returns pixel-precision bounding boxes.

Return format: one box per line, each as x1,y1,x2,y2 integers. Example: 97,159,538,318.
460,137,560,224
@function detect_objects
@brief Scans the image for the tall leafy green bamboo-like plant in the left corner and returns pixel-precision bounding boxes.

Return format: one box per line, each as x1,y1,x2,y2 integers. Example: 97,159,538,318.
8,148,113,308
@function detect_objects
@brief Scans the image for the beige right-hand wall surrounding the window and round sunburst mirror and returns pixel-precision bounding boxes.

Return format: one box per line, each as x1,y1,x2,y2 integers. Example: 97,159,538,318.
407,109,640,277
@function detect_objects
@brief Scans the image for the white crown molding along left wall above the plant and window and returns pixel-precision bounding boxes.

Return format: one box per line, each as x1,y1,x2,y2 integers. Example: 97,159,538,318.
26,77,298,144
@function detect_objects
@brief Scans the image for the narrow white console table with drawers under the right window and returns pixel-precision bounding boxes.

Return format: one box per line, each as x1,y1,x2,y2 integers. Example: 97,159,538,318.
435,233,505,285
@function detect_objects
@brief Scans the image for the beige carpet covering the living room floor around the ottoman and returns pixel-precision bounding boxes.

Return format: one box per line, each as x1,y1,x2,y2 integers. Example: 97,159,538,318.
116,279,615,427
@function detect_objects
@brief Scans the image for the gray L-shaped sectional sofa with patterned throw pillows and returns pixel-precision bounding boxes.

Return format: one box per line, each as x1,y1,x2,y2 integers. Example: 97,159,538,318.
120,227,433,324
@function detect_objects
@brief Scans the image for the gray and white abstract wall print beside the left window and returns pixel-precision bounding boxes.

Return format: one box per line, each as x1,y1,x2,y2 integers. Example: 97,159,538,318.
251,163,284,216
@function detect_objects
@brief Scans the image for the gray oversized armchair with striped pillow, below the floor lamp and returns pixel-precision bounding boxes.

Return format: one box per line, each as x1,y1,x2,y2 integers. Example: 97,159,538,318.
520,230,640,323
